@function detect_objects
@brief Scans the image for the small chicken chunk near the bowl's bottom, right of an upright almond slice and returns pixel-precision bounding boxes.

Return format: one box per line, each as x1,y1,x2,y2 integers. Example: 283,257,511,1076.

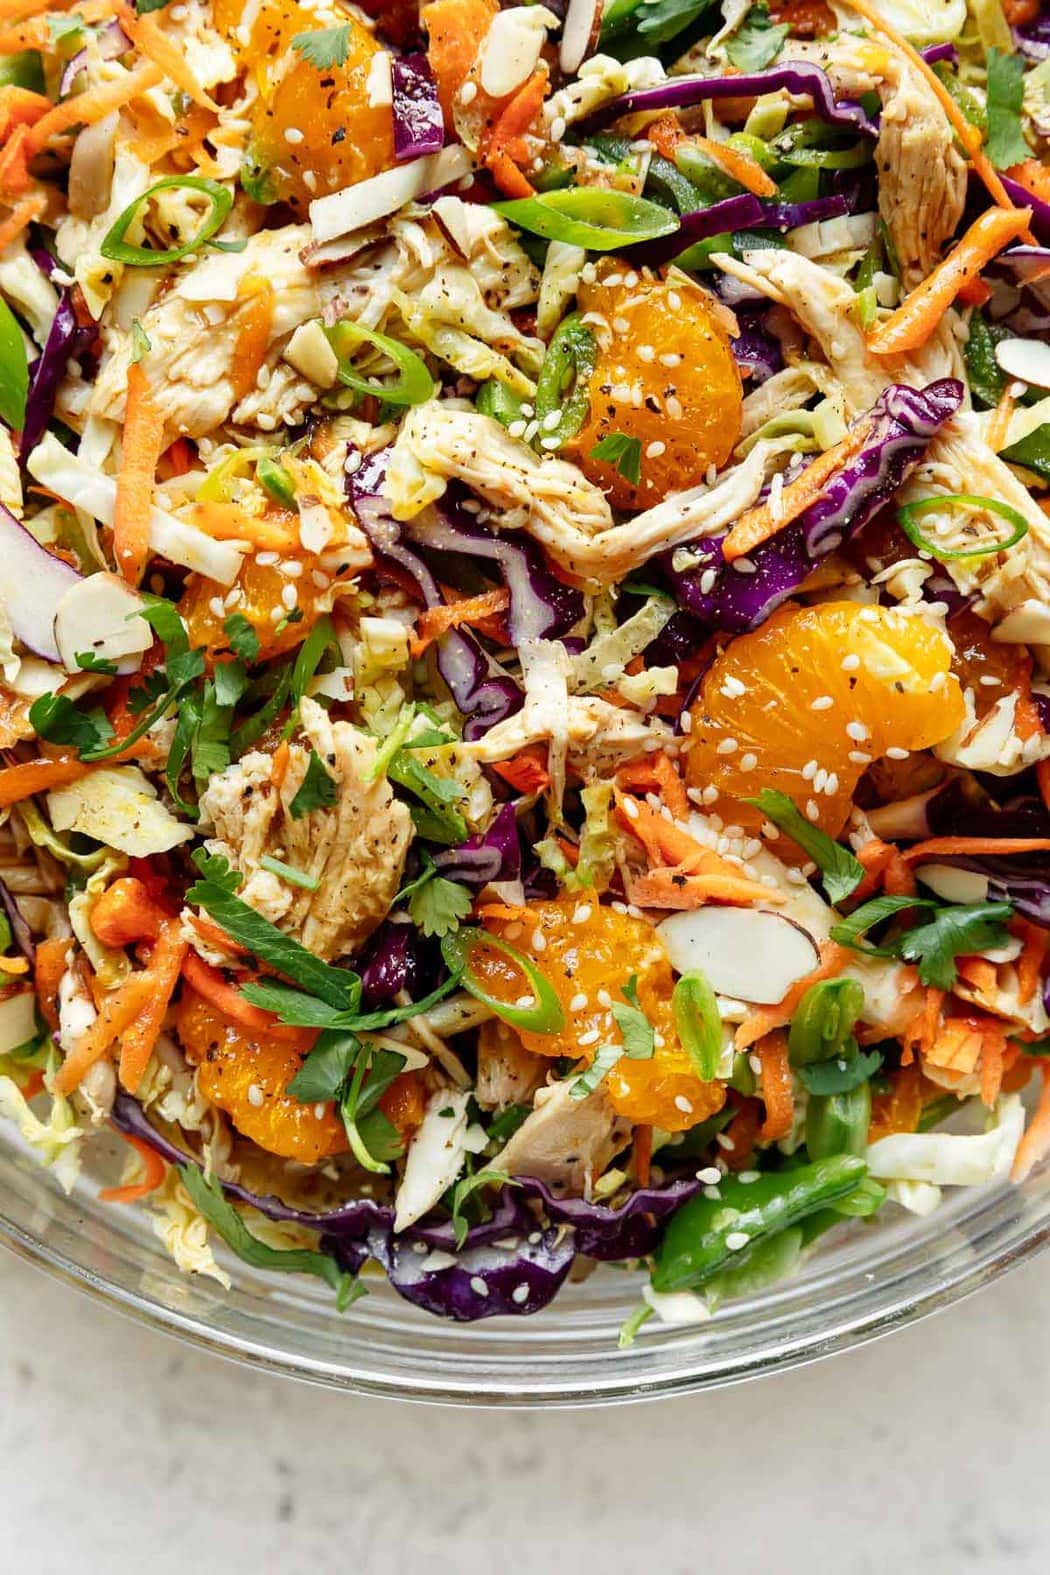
493,1080,631,1194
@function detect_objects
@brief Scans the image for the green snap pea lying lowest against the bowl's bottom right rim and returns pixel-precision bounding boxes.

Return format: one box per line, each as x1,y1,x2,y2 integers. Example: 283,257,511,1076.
653,1154,867,1292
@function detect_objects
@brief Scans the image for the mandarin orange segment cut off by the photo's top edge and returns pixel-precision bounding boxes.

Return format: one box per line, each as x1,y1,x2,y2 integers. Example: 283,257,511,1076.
223,0,394,214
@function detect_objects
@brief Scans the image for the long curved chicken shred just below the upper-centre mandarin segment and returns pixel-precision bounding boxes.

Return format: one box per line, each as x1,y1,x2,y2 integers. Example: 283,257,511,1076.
387,403,771,584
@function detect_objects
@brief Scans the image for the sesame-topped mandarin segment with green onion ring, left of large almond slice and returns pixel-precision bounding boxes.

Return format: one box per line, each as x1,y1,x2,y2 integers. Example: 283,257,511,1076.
474,898,726,1132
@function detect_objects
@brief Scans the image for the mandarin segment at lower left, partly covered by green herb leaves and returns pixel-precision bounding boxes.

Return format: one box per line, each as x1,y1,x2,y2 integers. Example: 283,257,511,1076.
176,988,346,1166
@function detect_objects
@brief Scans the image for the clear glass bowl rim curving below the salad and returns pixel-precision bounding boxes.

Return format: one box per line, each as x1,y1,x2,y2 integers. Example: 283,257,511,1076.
0,1129,1050,1405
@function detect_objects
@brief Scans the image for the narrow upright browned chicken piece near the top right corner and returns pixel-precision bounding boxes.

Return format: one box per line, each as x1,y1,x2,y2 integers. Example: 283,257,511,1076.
875,60,967,290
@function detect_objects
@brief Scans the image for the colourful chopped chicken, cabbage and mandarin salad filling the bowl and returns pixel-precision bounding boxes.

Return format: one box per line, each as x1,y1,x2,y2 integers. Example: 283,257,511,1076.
0,0,1050,1340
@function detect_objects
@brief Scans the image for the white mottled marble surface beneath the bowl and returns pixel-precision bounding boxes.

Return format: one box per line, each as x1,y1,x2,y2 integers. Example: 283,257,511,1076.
0,1254,1050,1575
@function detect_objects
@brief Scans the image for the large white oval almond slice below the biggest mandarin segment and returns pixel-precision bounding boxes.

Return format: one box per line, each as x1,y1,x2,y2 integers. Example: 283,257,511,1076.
656,907,820,1006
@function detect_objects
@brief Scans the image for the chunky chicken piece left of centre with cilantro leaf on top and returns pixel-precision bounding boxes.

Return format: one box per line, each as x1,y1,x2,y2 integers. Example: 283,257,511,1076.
200,699,412,961
